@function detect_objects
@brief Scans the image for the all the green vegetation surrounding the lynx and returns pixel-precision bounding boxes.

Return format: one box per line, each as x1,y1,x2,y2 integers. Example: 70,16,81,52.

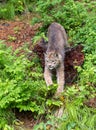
0,0,96,130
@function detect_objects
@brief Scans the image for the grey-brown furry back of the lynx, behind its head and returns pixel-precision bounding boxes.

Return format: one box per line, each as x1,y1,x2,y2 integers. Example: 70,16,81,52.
47,22,69,57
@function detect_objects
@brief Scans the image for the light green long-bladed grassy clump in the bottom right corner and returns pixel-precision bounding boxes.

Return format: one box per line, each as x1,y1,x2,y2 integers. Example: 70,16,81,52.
34,102,96,130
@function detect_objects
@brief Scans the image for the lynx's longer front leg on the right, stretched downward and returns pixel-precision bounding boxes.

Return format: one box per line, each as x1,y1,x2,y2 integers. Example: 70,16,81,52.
55,63,65,96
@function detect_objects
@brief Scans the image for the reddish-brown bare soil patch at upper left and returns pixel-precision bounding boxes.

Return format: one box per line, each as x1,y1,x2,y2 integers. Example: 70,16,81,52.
0,21,40,50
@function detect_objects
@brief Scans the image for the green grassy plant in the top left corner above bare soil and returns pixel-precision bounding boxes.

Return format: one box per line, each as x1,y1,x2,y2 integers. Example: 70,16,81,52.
0,0,29,20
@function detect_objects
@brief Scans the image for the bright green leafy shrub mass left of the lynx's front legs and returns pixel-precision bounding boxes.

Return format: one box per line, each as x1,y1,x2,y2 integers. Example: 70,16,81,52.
0,41,61,128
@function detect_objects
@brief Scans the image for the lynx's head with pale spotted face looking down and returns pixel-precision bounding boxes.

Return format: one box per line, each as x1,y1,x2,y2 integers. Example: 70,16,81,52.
45,51,62,70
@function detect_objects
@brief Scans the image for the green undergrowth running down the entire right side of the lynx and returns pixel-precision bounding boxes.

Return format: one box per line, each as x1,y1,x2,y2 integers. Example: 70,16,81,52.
32,0,96,130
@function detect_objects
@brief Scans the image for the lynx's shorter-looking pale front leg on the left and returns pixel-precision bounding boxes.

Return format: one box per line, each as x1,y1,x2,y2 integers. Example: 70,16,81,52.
44,67,53,86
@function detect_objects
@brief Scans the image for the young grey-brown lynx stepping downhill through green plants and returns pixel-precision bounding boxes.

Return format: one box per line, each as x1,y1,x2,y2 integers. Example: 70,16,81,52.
44,22,69,95
